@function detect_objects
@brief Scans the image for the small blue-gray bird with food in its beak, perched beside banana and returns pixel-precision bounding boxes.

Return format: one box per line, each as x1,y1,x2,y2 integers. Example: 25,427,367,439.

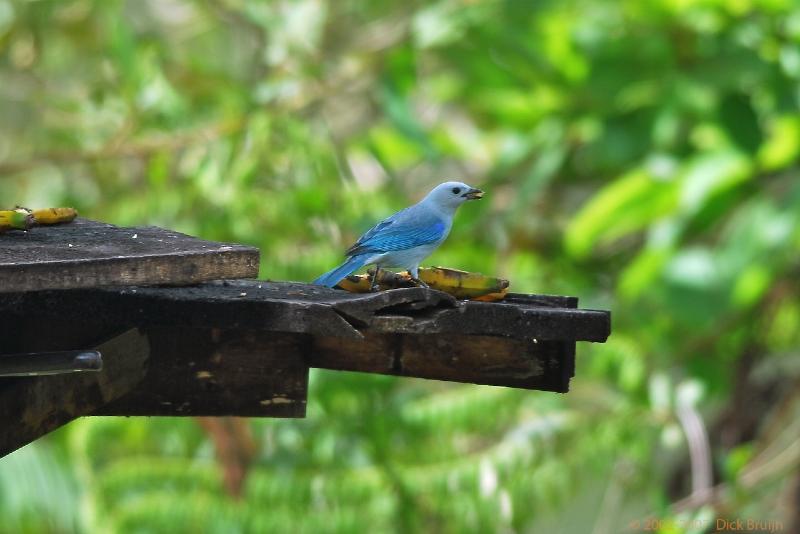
313,182,483,294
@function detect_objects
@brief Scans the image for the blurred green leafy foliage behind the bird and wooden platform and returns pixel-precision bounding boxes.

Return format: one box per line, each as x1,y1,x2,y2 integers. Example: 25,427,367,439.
0,0,800,533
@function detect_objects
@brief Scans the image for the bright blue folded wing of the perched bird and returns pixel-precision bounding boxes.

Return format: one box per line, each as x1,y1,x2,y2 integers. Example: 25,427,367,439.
347,218,447,256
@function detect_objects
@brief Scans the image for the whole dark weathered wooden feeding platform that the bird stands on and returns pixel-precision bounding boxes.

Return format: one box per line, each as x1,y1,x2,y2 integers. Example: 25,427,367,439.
0,219,610,455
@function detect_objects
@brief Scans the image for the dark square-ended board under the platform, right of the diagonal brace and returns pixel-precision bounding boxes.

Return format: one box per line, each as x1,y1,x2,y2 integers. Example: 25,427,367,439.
94,327,308,417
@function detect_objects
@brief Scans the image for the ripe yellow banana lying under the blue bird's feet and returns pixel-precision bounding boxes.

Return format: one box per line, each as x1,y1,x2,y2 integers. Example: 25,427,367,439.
339,267,508,302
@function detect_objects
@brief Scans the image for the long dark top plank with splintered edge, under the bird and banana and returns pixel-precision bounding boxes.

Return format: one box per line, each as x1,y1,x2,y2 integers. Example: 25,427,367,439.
0,280,611,342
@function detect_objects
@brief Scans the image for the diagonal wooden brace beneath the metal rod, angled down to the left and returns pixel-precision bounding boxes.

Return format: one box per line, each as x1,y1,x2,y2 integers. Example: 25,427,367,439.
0,330,149,456
